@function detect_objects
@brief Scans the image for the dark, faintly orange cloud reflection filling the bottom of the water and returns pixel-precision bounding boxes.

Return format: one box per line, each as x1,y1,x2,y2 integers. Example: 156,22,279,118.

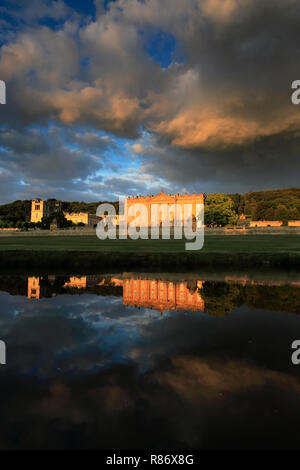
0,355,300,449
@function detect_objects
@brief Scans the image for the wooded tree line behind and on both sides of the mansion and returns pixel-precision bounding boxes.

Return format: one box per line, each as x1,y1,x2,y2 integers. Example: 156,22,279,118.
0,188,300,228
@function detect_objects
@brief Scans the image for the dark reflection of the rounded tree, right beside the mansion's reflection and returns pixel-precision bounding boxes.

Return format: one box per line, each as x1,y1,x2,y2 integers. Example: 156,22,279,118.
199,281,241,316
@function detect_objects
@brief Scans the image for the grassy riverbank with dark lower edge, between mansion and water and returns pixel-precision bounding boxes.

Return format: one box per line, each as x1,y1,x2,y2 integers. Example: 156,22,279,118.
0,235,300,272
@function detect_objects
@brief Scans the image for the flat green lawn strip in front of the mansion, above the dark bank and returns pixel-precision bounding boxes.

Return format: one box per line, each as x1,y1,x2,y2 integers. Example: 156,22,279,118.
0,235,300,254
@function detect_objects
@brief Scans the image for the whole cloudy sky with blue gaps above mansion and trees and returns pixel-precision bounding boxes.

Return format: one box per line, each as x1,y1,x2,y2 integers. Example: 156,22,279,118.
0,0,300,203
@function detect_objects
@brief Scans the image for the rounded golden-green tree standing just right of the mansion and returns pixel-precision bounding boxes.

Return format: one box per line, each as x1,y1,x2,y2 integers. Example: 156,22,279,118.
204,193,238,226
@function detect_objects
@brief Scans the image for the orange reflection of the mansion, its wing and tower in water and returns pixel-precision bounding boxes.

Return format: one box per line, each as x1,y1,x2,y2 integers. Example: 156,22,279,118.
28,276,205,312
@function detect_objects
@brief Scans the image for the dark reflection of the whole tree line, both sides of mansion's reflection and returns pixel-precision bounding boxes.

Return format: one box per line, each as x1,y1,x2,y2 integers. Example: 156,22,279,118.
0,275,300,316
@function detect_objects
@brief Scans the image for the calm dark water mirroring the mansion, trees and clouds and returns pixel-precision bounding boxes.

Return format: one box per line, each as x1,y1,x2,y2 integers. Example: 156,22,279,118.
0,273,300,449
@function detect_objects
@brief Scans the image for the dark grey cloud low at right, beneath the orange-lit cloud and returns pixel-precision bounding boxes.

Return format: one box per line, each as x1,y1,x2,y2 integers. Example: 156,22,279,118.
139,132,300,192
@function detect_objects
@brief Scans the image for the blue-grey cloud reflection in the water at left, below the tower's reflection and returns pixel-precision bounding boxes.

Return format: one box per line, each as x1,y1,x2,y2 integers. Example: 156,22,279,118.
0,293,165,376
